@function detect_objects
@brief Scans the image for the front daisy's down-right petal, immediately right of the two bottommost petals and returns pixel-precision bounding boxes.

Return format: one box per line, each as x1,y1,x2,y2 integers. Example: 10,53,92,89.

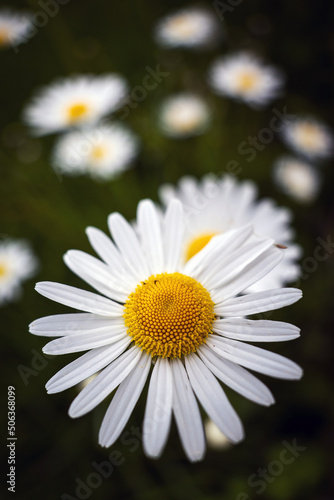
185,354,244,443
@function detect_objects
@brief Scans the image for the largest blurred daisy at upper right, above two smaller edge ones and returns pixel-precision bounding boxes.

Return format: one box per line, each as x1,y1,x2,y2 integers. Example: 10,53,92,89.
209,52,284,106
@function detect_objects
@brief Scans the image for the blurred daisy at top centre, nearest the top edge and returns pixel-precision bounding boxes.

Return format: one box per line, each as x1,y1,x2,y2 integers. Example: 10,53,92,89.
154,7,221,49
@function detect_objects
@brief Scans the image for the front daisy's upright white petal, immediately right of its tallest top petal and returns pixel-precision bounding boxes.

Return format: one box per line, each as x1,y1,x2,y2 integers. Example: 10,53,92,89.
163,200,184,273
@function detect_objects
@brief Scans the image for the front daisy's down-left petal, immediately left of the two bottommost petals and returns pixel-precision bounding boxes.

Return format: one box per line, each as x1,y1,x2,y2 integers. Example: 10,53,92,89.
99,353,151,447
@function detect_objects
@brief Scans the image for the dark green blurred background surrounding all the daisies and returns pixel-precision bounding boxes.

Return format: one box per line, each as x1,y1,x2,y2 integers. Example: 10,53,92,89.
0,0,334,500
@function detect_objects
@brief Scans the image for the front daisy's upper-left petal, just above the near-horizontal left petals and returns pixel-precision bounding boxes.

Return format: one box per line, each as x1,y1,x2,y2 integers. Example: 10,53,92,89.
64,250,131,302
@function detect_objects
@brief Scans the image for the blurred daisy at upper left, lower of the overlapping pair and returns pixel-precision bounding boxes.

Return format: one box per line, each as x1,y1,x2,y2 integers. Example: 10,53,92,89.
53,123,138,180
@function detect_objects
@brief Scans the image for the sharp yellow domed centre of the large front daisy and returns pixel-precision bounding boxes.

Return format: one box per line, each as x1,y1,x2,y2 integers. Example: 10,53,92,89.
124,273,215,358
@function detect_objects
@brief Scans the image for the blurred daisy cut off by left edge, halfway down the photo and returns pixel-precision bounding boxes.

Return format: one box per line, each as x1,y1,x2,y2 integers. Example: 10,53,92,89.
0,239,37,305
